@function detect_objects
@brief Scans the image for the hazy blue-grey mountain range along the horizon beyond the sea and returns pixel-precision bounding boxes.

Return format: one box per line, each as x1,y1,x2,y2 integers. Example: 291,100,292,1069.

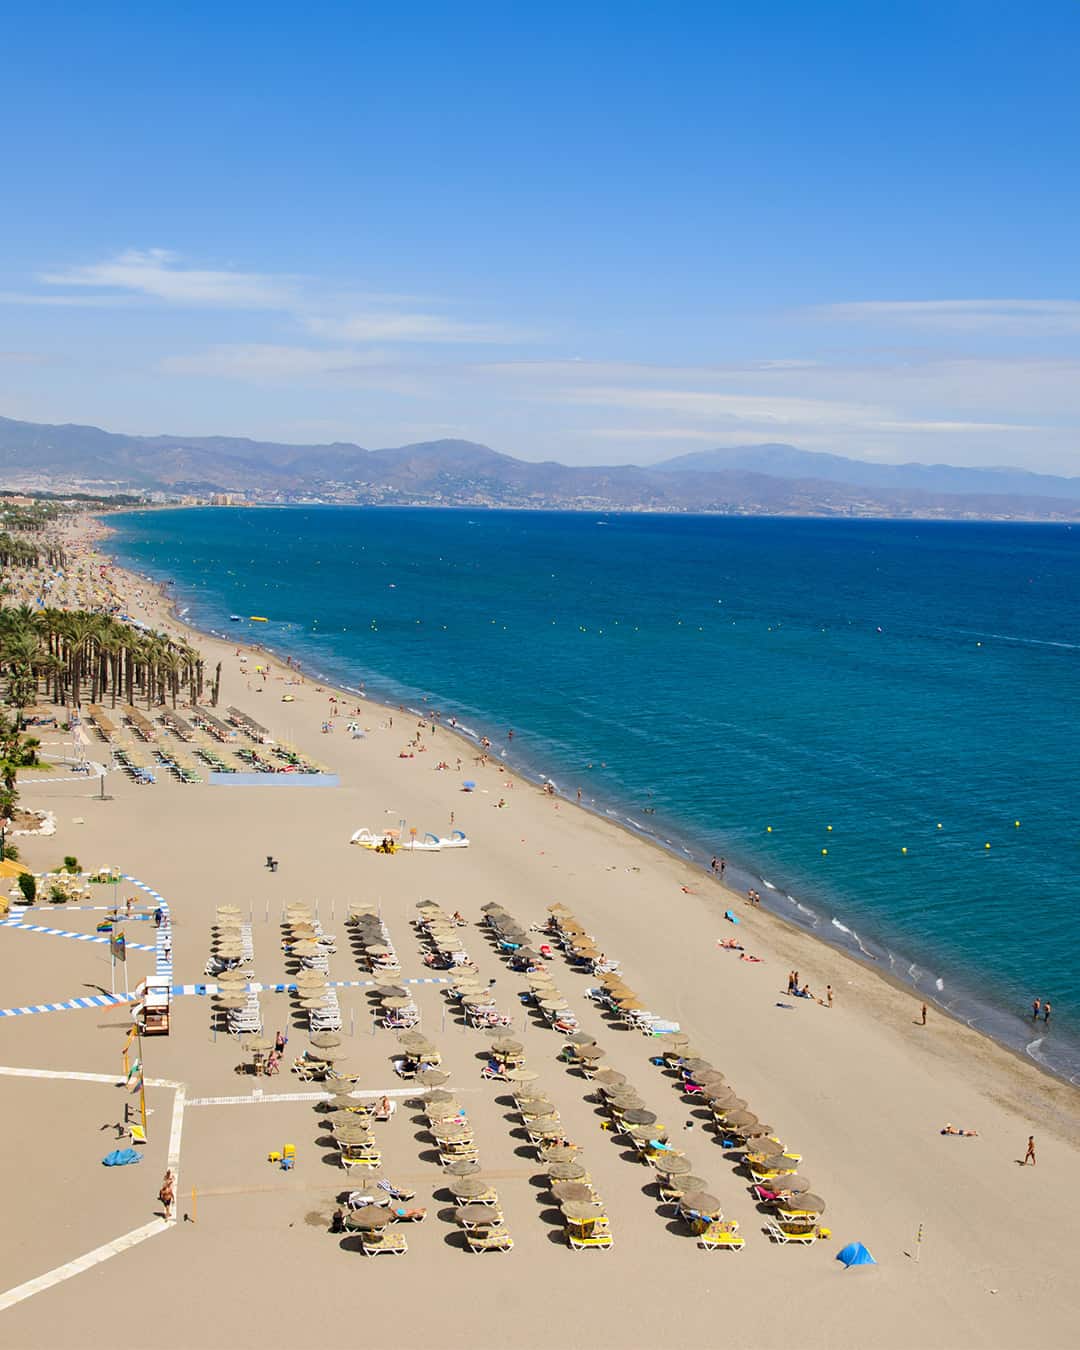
0,417,1080,520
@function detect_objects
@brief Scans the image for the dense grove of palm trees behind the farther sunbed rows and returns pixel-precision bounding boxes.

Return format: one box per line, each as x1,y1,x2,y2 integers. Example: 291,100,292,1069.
0,605,204,710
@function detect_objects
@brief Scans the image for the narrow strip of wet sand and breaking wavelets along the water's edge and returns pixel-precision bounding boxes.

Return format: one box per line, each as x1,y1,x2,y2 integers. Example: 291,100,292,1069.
93,510,1080,1103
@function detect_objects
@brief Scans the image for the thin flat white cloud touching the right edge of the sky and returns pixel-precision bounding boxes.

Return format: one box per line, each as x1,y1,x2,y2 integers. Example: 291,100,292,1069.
810,300,1080,338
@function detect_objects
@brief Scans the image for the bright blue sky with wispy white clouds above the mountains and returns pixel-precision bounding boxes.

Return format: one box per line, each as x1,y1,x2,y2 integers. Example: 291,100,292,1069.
0,0,1080,474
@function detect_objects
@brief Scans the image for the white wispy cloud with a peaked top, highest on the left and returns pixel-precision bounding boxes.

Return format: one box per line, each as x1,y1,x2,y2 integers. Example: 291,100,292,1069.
38,248,297,309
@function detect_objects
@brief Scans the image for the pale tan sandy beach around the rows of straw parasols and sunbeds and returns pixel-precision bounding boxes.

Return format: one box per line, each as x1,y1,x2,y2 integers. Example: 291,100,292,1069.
0,520,1080,1350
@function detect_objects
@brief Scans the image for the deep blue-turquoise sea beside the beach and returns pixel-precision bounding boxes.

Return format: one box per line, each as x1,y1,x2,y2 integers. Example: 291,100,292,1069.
109,508,1080,1081
